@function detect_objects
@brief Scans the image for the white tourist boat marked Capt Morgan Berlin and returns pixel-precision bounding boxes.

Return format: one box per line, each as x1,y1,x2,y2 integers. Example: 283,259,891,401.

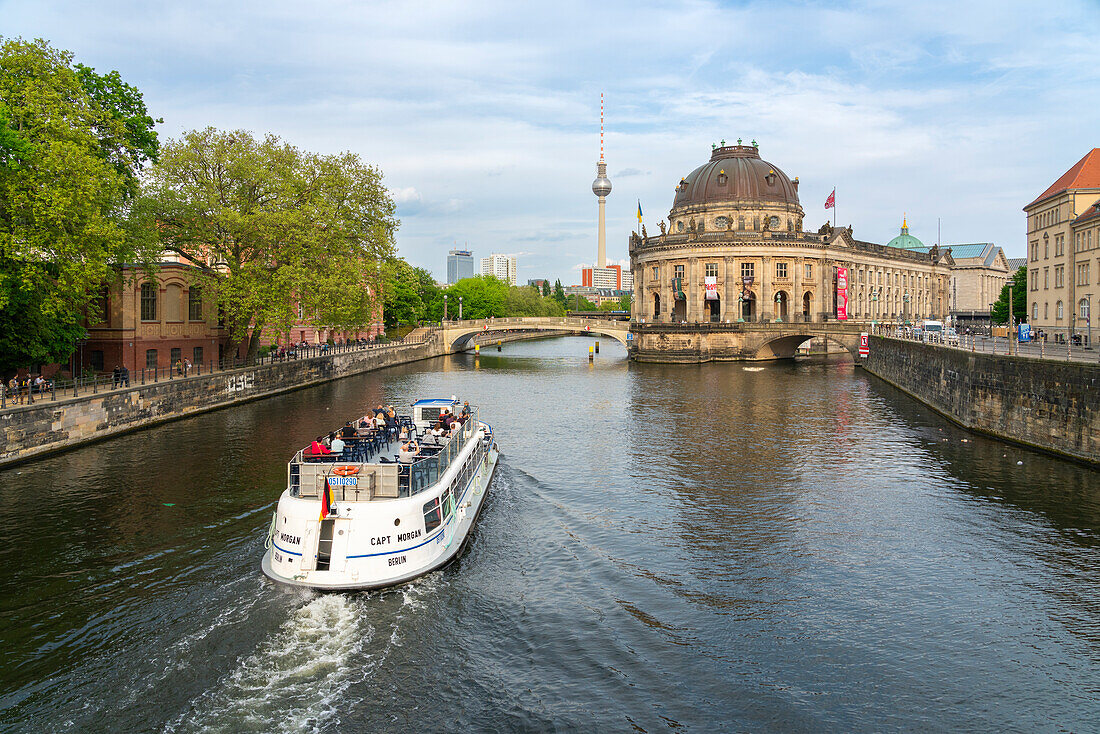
261,398,497,591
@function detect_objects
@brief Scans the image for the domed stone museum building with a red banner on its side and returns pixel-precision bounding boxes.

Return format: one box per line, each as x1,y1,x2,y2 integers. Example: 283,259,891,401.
630,141,952,361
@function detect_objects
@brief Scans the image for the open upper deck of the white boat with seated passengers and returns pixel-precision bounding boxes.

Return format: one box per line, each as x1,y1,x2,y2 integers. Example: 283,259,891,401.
287,398,481,502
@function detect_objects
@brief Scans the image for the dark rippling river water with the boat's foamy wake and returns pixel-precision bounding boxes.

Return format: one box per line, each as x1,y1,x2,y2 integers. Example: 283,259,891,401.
0,338,1100,732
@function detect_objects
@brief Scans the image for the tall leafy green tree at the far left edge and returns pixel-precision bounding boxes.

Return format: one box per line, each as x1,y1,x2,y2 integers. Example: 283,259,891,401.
0,39,156,369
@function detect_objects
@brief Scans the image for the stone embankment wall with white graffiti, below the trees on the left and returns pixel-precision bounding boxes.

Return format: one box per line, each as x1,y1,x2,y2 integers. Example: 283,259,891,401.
0,338,446,465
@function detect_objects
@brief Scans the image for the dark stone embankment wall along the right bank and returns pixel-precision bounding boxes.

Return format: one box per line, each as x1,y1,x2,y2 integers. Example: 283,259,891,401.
860,337,1100,467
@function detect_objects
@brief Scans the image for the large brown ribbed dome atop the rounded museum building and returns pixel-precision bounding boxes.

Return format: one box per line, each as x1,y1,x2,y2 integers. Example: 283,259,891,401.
672,145,800,209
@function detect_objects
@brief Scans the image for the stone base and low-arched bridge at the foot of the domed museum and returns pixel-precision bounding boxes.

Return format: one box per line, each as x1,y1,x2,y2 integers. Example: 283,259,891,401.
630,321,870,362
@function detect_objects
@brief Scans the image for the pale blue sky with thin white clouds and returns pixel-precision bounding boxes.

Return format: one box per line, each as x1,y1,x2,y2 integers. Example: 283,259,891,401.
0,0,1100,285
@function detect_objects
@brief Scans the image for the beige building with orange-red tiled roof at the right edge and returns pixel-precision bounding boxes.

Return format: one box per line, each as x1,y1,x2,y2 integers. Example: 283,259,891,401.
1024,147,1100,341
